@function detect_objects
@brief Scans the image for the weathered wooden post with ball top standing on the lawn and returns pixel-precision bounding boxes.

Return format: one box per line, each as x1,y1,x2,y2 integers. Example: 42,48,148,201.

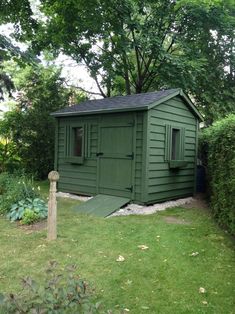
47,171,60,241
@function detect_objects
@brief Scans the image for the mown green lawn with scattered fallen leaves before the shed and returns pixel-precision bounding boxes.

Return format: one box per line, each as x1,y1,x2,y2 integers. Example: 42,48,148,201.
0,184,235,314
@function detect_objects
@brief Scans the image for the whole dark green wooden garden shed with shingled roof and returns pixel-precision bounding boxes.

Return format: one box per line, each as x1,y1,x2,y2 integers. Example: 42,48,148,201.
52,89,202,204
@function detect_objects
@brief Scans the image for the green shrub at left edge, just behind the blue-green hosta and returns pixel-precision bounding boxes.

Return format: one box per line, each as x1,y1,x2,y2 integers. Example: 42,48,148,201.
0,173,39,214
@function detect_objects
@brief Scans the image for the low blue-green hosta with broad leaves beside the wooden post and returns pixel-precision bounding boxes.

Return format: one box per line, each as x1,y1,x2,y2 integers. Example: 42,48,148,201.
7,198,48,222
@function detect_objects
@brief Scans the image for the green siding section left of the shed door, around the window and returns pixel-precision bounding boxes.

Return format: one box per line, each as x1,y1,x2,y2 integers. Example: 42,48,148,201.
57,117,98,195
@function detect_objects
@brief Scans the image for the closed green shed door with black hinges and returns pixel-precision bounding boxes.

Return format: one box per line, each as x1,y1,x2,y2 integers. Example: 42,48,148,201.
98,124,134,198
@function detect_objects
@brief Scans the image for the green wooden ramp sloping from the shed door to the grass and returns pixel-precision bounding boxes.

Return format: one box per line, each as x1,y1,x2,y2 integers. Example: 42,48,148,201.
73,194,130,217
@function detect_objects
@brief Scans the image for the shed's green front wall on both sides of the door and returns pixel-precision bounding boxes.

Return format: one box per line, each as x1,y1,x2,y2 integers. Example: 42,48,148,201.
55,112,146,202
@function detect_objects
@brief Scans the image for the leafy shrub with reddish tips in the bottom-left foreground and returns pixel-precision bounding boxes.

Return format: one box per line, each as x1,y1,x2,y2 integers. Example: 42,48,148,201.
0,261,99,314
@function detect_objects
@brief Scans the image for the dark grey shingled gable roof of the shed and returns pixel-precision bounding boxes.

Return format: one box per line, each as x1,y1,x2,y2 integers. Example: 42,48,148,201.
52,88,203,120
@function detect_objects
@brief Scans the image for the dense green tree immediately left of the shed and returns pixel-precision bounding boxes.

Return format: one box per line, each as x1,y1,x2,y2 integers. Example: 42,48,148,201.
0,64,72,179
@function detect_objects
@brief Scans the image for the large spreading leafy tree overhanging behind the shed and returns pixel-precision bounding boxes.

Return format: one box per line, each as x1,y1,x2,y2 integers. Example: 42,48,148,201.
0,0,235,121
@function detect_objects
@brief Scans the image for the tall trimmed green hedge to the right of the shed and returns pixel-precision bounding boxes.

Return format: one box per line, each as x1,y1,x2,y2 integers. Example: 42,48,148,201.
199,114,235,234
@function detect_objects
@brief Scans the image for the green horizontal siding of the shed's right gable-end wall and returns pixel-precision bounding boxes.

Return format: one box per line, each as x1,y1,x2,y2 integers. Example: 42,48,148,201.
147,97,197,203
